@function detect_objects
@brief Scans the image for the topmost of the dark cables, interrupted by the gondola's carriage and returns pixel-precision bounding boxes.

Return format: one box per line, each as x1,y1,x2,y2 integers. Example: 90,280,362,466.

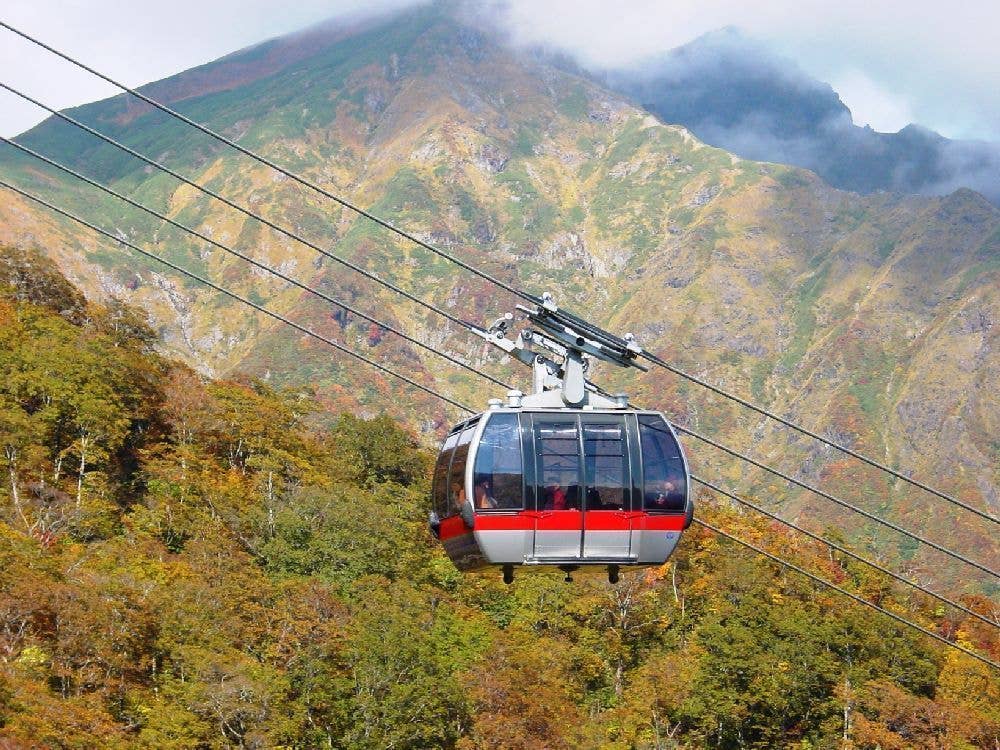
0,25,1000,524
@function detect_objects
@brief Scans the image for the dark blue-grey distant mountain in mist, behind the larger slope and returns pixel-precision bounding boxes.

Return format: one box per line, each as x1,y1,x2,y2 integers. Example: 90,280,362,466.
596,28,1000,205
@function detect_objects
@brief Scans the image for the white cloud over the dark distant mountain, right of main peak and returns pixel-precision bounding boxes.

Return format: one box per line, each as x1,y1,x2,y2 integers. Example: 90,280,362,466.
492,0,1000,140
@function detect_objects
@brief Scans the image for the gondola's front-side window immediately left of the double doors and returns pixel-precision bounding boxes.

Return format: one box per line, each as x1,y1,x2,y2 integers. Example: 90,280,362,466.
472,414,524,510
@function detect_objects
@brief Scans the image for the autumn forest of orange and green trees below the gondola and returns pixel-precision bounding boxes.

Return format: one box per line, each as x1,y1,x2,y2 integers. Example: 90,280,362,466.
0,242,1000,750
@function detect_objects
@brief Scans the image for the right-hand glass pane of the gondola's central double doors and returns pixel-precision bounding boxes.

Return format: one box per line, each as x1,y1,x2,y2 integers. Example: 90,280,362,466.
583,419,631,510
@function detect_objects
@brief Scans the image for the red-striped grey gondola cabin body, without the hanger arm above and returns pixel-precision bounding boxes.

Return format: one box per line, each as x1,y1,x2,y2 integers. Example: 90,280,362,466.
433,405,692,578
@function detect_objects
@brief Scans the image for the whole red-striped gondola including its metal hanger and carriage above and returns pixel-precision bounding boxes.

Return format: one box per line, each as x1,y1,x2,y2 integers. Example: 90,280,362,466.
430,295,693,583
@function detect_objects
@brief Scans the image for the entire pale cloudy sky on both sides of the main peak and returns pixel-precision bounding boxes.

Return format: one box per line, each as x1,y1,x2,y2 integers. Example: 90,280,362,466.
0,0,1000,141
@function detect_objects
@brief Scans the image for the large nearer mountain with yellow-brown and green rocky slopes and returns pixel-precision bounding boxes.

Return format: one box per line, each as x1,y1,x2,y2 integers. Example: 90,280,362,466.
0,5,1000,592
